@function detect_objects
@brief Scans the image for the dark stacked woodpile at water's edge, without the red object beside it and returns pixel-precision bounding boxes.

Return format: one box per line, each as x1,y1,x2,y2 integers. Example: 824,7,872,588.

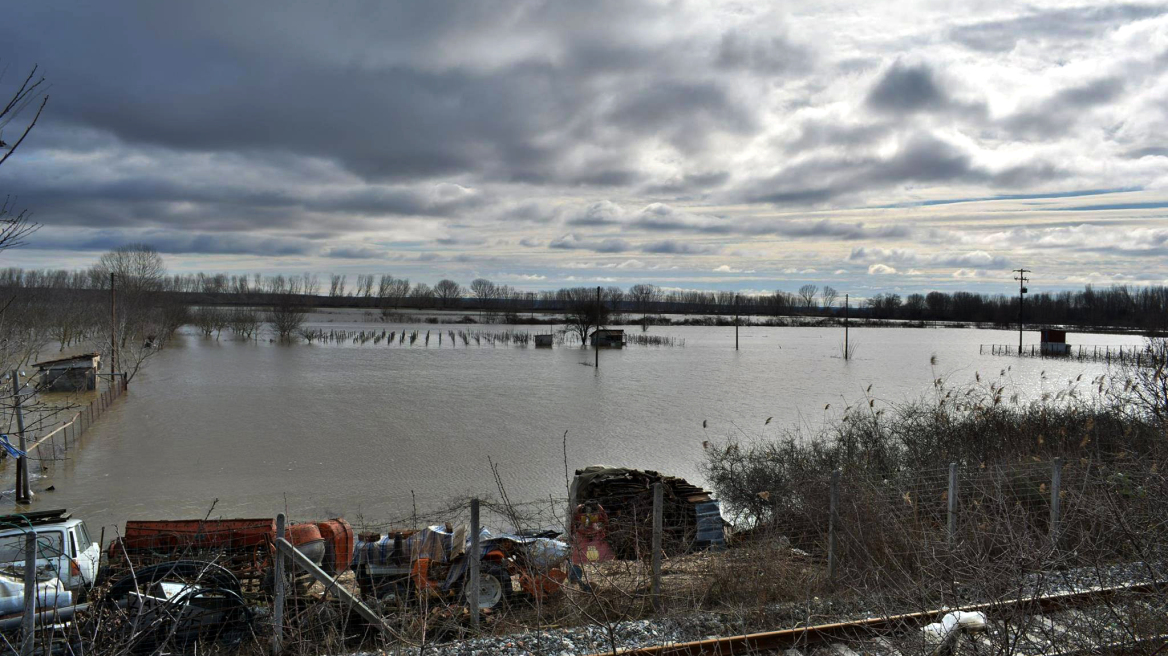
570,466,722,559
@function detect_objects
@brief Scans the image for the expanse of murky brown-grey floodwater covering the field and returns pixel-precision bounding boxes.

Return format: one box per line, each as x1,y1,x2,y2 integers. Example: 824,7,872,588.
4,313,1140,526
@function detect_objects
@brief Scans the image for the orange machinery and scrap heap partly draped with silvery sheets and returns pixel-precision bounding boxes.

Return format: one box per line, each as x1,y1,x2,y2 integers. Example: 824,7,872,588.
353,525,568,610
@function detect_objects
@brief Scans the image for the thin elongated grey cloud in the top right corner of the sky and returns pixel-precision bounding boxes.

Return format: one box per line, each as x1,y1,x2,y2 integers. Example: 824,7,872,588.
950,4,1168,51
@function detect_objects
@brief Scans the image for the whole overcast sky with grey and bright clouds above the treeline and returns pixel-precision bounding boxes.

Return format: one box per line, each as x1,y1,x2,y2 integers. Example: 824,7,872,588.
0,0,1168,290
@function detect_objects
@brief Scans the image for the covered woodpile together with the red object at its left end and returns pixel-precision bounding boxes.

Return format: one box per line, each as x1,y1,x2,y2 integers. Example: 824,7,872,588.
569,466,725,563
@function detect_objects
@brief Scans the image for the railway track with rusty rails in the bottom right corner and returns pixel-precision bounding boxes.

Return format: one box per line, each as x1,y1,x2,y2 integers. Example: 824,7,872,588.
593,581,1168,656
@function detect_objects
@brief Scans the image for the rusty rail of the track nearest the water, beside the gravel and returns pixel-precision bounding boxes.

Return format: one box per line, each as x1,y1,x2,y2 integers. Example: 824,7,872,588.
591,581,1168,656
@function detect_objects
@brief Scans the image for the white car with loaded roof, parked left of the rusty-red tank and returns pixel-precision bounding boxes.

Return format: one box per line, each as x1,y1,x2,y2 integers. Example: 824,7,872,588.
0,510,102,602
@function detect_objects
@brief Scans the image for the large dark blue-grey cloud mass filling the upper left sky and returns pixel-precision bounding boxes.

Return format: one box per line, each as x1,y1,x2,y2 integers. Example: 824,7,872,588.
9,1,756,186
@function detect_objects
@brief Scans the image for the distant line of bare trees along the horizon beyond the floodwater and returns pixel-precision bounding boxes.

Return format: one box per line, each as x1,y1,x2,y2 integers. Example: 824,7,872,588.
0,267,1168,332
